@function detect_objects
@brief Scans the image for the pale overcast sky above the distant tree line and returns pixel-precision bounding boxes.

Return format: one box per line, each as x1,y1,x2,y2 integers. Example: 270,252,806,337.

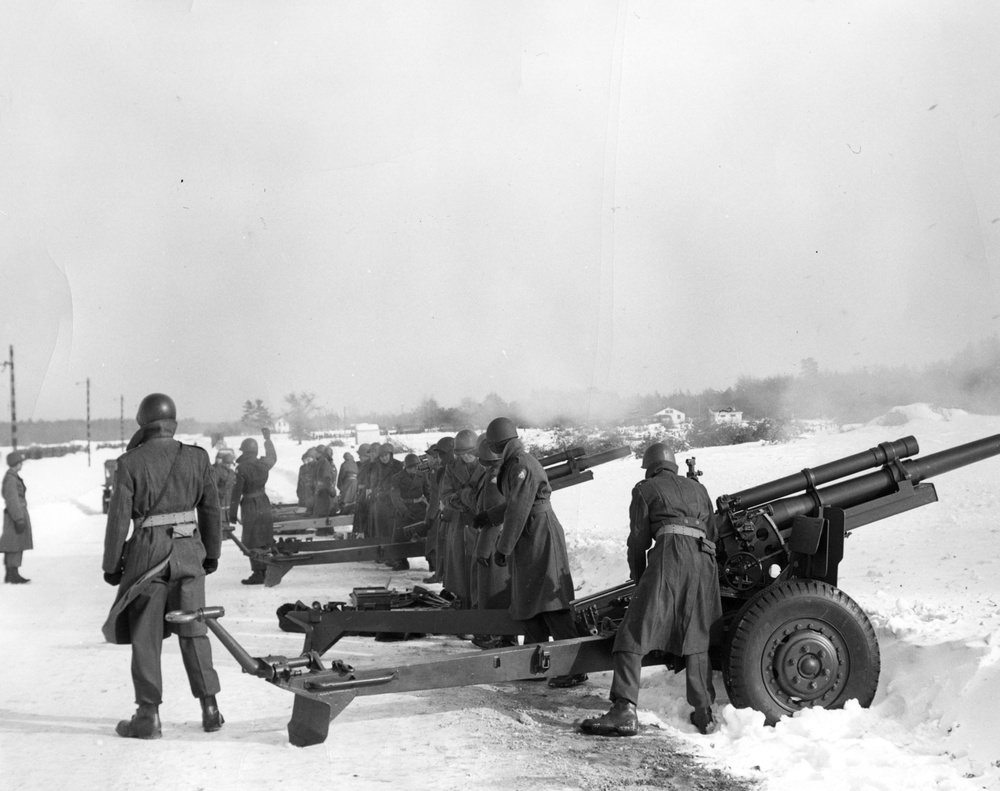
0,0,1000,420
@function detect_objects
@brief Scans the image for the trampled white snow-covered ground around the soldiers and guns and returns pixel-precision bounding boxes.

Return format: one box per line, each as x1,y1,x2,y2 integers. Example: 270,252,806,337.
0,405,1000,791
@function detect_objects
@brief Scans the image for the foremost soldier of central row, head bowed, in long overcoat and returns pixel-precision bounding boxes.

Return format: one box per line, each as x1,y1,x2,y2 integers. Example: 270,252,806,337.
475,417,587,687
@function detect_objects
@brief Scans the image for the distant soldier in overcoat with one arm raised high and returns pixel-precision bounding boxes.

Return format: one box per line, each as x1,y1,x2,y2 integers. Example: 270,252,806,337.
229,428,278,585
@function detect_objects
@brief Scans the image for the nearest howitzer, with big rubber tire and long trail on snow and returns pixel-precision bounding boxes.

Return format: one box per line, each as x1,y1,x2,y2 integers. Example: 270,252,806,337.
184,435,1000,746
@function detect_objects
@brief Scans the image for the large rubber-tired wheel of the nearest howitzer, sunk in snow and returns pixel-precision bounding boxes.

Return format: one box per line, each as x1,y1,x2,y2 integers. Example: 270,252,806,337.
723,580,881,725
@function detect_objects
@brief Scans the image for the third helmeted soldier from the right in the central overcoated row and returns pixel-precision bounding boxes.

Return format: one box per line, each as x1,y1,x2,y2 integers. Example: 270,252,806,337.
440,428,486,607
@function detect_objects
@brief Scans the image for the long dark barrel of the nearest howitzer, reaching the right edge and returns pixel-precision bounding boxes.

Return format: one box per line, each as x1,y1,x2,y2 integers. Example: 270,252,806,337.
769,434,1000,528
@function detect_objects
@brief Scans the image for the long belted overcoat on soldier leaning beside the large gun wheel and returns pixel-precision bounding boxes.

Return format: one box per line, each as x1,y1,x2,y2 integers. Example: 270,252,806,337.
614,469,722,656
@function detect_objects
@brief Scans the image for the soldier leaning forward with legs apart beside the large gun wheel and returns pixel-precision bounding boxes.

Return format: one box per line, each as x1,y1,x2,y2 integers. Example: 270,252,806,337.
580,442,722,736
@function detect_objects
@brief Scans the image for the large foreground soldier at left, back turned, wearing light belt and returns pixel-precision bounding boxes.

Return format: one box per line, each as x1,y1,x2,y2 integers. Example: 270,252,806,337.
103,393,224,739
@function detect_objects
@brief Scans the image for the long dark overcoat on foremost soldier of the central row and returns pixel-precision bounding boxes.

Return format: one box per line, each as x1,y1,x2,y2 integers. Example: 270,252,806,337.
496,439,573,621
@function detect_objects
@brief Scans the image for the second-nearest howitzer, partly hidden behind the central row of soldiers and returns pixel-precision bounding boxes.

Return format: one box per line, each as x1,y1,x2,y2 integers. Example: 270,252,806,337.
230,447,632,588
